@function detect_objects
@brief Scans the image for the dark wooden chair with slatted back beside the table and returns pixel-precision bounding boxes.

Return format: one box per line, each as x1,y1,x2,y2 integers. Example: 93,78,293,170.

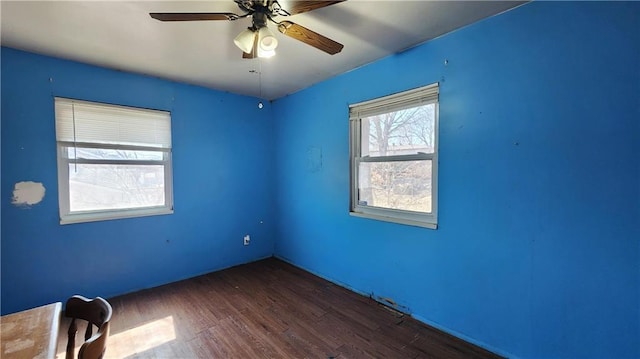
65,295,113,359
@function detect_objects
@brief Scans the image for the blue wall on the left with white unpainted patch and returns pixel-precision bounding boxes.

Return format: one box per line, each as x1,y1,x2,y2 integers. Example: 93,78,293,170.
1,48,274,314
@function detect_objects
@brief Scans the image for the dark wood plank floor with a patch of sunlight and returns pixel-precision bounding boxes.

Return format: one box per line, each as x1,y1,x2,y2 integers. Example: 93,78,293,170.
58,258,499,359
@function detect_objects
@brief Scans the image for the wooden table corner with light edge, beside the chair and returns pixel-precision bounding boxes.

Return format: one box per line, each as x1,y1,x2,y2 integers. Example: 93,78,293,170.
0,302,62,359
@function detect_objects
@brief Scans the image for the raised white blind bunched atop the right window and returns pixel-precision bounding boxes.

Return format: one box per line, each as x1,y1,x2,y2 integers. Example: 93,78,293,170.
349,83,439,120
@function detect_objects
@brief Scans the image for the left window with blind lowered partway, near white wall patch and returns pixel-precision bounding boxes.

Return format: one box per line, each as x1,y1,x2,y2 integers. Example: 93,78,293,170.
55,98,173,224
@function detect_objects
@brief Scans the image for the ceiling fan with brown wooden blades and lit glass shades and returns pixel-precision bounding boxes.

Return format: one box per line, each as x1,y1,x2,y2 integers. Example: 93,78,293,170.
149,0,345,59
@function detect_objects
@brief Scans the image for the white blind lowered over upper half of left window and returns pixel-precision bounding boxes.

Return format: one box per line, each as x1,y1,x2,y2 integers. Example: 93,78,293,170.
55,97,171,149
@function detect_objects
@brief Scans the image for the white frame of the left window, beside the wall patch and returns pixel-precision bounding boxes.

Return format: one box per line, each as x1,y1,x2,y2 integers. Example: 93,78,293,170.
54,97,173,224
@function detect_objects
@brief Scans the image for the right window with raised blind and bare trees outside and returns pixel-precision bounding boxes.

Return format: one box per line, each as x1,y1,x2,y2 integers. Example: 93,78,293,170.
349,83,438,229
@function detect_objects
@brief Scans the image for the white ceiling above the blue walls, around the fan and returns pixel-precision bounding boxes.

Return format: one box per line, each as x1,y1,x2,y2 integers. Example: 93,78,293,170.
0,0,522,99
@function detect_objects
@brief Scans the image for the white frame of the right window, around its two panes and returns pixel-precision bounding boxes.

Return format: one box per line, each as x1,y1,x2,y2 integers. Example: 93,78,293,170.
349,83,439,229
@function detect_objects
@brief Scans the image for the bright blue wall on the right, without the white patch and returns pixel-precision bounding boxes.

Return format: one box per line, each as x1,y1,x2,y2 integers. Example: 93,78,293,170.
273,2,640,358
